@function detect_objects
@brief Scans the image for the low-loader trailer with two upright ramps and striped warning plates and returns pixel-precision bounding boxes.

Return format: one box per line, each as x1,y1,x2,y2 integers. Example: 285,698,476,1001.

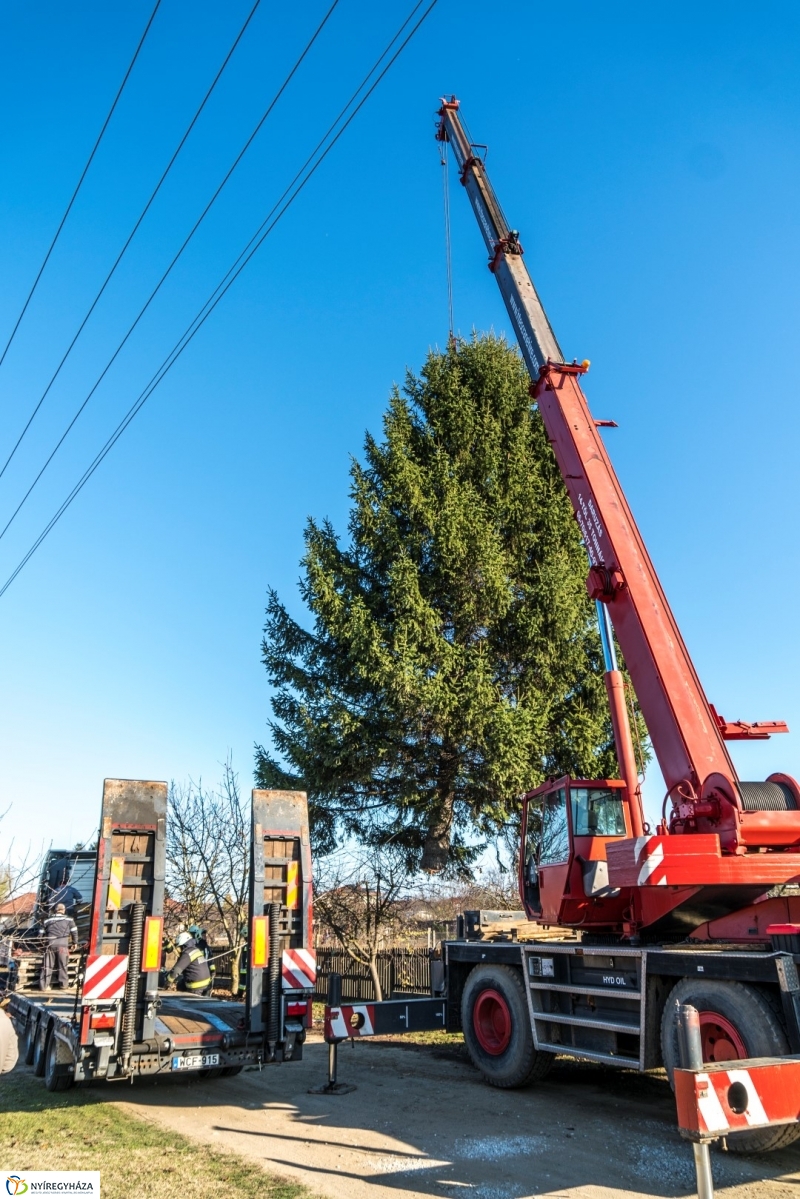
8,778,315,1091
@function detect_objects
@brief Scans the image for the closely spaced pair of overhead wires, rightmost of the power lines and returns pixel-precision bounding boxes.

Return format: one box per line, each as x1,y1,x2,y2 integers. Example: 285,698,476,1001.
0,0,438,597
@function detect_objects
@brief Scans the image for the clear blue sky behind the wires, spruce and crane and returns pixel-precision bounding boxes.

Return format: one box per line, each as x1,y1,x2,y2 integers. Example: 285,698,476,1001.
0,0,800,858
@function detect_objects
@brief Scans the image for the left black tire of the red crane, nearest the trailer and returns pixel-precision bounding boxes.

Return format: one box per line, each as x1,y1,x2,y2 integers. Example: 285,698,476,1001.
461,965,553,1089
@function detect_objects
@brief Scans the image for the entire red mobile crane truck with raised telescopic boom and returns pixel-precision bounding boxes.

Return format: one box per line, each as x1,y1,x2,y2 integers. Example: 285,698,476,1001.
326,97,800,1152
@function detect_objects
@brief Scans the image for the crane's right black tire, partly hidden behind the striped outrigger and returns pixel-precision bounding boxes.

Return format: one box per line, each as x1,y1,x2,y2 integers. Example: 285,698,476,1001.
661,978,800,1153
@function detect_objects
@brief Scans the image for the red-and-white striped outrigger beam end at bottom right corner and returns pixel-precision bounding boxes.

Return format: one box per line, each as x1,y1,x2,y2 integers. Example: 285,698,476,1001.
675,1058,800,1140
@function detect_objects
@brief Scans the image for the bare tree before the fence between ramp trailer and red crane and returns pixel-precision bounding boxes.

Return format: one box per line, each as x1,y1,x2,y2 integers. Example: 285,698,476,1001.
314,849,408,1000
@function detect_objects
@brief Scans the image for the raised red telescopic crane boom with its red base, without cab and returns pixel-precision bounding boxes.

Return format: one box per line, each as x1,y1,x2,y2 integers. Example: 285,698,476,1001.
437,97,800,927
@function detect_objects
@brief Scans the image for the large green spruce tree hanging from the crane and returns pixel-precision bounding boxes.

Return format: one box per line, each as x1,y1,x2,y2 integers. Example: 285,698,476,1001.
257,337,618,870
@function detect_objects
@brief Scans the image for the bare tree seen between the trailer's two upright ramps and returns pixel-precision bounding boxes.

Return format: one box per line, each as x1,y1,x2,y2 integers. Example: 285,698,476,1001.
167,758,249,994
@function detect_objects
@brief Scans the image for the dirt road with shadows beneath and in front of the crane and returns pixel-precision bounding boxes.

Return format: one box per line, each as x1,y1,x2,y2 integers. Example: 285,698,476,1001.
113,1042,800,1199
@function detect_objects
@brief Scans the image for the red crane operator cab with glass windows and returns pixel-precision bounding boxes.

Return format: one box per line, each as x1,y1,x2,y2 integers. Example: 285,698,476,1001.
521,778,632,929
